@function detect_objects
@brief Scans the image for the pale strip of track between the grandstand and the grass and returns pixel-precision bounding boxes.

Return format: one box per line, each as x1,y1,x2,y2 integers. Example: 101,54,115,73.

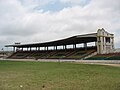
2,59,120,67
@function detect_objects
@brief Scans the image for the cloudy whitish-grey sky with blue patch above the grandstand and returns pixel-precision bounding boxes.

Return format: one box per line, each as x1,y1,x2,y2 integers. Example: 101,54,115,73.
0,0,120,49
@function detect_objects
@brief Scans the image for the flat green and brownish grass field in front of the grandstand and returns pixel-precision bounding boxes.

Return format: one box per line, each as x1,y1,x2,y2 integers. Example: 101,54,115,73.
0,61,120,90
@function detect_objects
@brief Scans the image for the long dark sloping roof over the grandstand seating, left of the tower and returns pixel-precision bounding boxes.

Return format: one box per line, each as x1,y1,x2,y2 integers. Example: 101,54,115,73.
5,33,97,47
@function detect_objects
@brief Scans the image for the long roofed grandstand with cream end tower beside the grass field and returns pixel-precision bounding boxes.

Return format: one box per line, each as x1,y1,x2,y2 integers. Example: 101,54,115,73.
5,28,120,60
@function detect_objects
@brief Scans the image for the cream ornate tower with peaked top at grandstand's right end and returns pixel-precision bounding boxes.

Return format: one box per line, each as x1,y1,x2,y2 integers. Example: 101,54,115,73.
97,28,114,54
